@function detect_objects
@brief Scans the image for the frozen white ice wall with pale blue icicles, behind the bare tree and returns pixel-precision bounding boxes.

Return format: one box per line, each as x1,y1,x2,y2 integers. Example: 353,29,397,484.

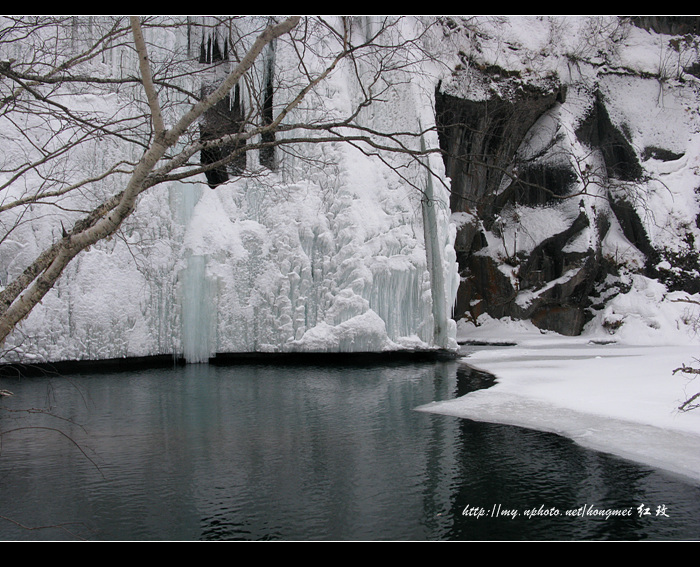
0,17,457,362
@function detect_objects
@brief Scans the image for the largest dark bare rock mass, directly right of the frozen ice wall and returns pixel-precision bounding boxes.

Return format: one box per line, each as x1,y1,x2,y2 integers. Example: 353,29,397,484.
436,76,595,334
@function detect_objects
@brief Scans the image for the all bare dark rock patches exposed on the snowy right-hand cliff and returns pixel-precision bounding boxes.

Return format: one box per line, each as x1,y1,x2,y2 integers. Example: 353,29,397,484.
436,70,700,335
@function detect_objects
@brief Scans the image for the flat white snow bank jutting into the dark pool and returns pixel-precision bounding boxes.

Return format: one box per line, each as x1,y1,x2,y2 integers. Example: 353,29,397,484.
417,302,700,482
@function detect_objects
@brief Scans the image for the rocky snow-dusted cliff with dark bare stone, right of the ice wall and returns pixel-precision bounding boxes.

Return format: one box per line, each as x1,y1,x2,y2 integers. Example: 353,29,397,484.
436,17,700,335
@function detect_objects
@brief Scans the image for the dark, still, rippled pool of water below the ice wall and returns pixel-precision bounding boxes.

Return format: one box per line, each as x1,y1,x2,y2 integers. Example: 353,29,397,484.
0,362,700,541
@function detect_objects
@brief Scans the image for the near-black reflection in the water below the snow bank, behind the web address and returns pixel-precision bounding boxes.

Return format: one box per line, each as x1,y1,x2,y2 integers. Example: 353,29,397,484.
445,420,700,540
